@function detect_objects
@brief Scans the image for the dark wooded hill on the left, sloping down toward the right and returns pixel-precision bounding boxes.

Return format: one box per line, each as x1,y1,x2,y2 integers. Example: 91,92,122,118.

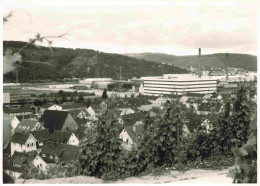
3,41,187,82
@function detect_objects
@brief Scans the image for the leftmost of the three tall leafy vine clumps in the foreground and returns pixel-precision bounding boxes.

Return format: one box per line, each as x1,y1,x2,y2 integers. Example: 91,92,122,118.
80,99,122,179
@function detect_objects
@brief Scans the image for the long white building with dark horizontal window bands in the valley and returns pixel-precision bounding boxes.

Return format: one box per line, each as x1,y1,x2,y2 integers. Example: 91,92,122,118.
141,74,217,96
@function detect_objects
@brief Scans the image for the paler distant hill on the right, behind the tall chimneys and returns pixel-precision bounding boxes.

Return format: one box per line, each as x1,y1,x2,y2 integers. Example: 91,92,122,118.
126,53,257,71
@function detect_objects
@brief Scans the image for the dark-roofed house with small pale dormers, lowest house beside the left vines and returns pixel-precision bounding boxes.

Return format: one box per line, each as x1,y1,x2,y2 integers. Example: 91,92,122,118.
39,141,79,164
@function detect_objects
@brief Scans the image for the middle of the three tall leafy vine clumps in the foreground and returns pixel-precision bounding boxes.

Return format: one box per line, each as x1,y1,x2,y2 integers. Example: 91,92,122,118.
133,102,186,174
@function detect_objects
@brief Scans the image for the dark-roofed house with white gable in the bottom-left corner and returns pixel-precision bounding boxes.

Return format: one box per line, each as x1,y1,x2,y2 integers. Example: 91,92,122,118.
5,152,48,178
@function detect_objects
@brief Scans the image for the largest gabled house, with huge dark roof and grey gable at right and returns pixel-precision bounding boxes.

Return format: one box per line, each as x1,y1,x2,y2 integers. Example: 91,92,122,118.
41,110,79,133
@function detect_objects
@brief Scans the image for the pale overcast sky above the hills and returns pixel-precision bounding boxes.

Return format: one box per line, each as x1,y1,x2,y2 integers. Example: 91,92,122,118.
3,0,258,55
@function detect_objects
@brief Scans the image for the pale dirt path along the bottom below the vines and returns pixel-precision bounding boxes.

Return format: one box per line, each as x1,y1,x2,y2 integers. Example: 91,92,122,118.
16,169,232,184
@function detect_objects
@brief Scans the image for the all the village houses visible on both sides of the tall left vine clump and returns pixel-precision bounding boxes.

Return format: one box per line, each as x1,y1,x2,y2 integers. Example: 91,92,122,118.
4,93,245,178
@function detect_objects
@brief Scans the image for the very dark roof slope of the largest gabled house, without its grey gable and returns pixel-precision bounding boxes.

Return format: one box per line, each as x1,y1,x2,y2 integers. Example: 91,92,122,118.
41,110,69,130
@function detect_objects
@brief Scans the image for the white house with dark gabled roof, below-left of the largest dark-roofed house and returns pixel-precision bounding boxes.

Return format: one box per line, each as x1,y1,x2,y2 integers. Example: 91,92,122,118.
11,133,37,156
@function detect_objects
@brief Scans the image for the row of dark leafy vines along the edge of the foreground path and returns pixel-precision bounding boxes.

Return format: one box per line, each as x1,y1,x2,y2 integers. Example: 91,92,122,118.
20,84,257,183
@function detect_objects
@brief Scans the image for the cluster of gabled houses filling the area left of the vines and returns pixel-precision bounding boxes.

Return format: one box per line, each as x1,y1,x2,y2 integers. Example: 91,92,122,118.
4,103,96,178
